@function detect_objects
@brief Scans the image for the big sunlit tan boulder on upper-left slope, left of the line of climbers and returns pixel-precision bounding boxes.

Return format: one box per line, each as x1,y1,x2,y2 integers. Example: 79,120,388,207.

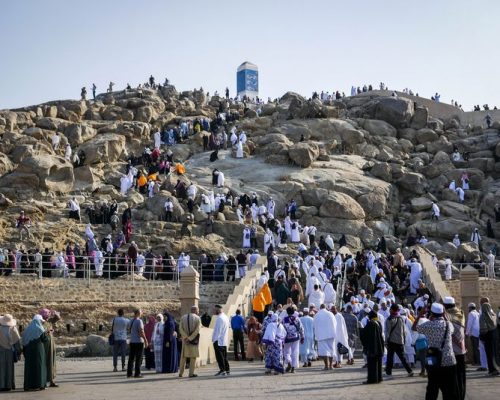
79,133,125,165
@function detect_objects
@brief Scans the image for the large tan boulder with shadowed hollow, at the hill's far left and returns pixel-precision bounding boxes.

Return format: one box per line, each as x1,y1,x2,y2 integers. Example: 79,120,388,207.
16,154,75,193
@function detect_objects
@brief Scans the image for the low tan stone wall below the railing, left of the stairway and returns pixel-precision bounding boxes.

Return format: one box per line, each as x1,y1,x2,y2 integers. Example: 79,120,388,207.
0,275,235,343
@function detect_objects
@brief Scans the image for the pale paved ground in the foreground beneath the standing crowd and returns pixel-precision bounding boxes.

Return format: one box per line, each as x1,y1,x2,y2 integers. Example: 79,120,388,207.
7,359,500,400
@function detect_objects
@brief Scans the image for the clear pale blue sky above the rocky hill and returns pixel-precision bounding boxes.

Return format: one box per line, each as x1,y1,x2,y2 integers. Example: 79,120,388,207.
0,0,500,110
